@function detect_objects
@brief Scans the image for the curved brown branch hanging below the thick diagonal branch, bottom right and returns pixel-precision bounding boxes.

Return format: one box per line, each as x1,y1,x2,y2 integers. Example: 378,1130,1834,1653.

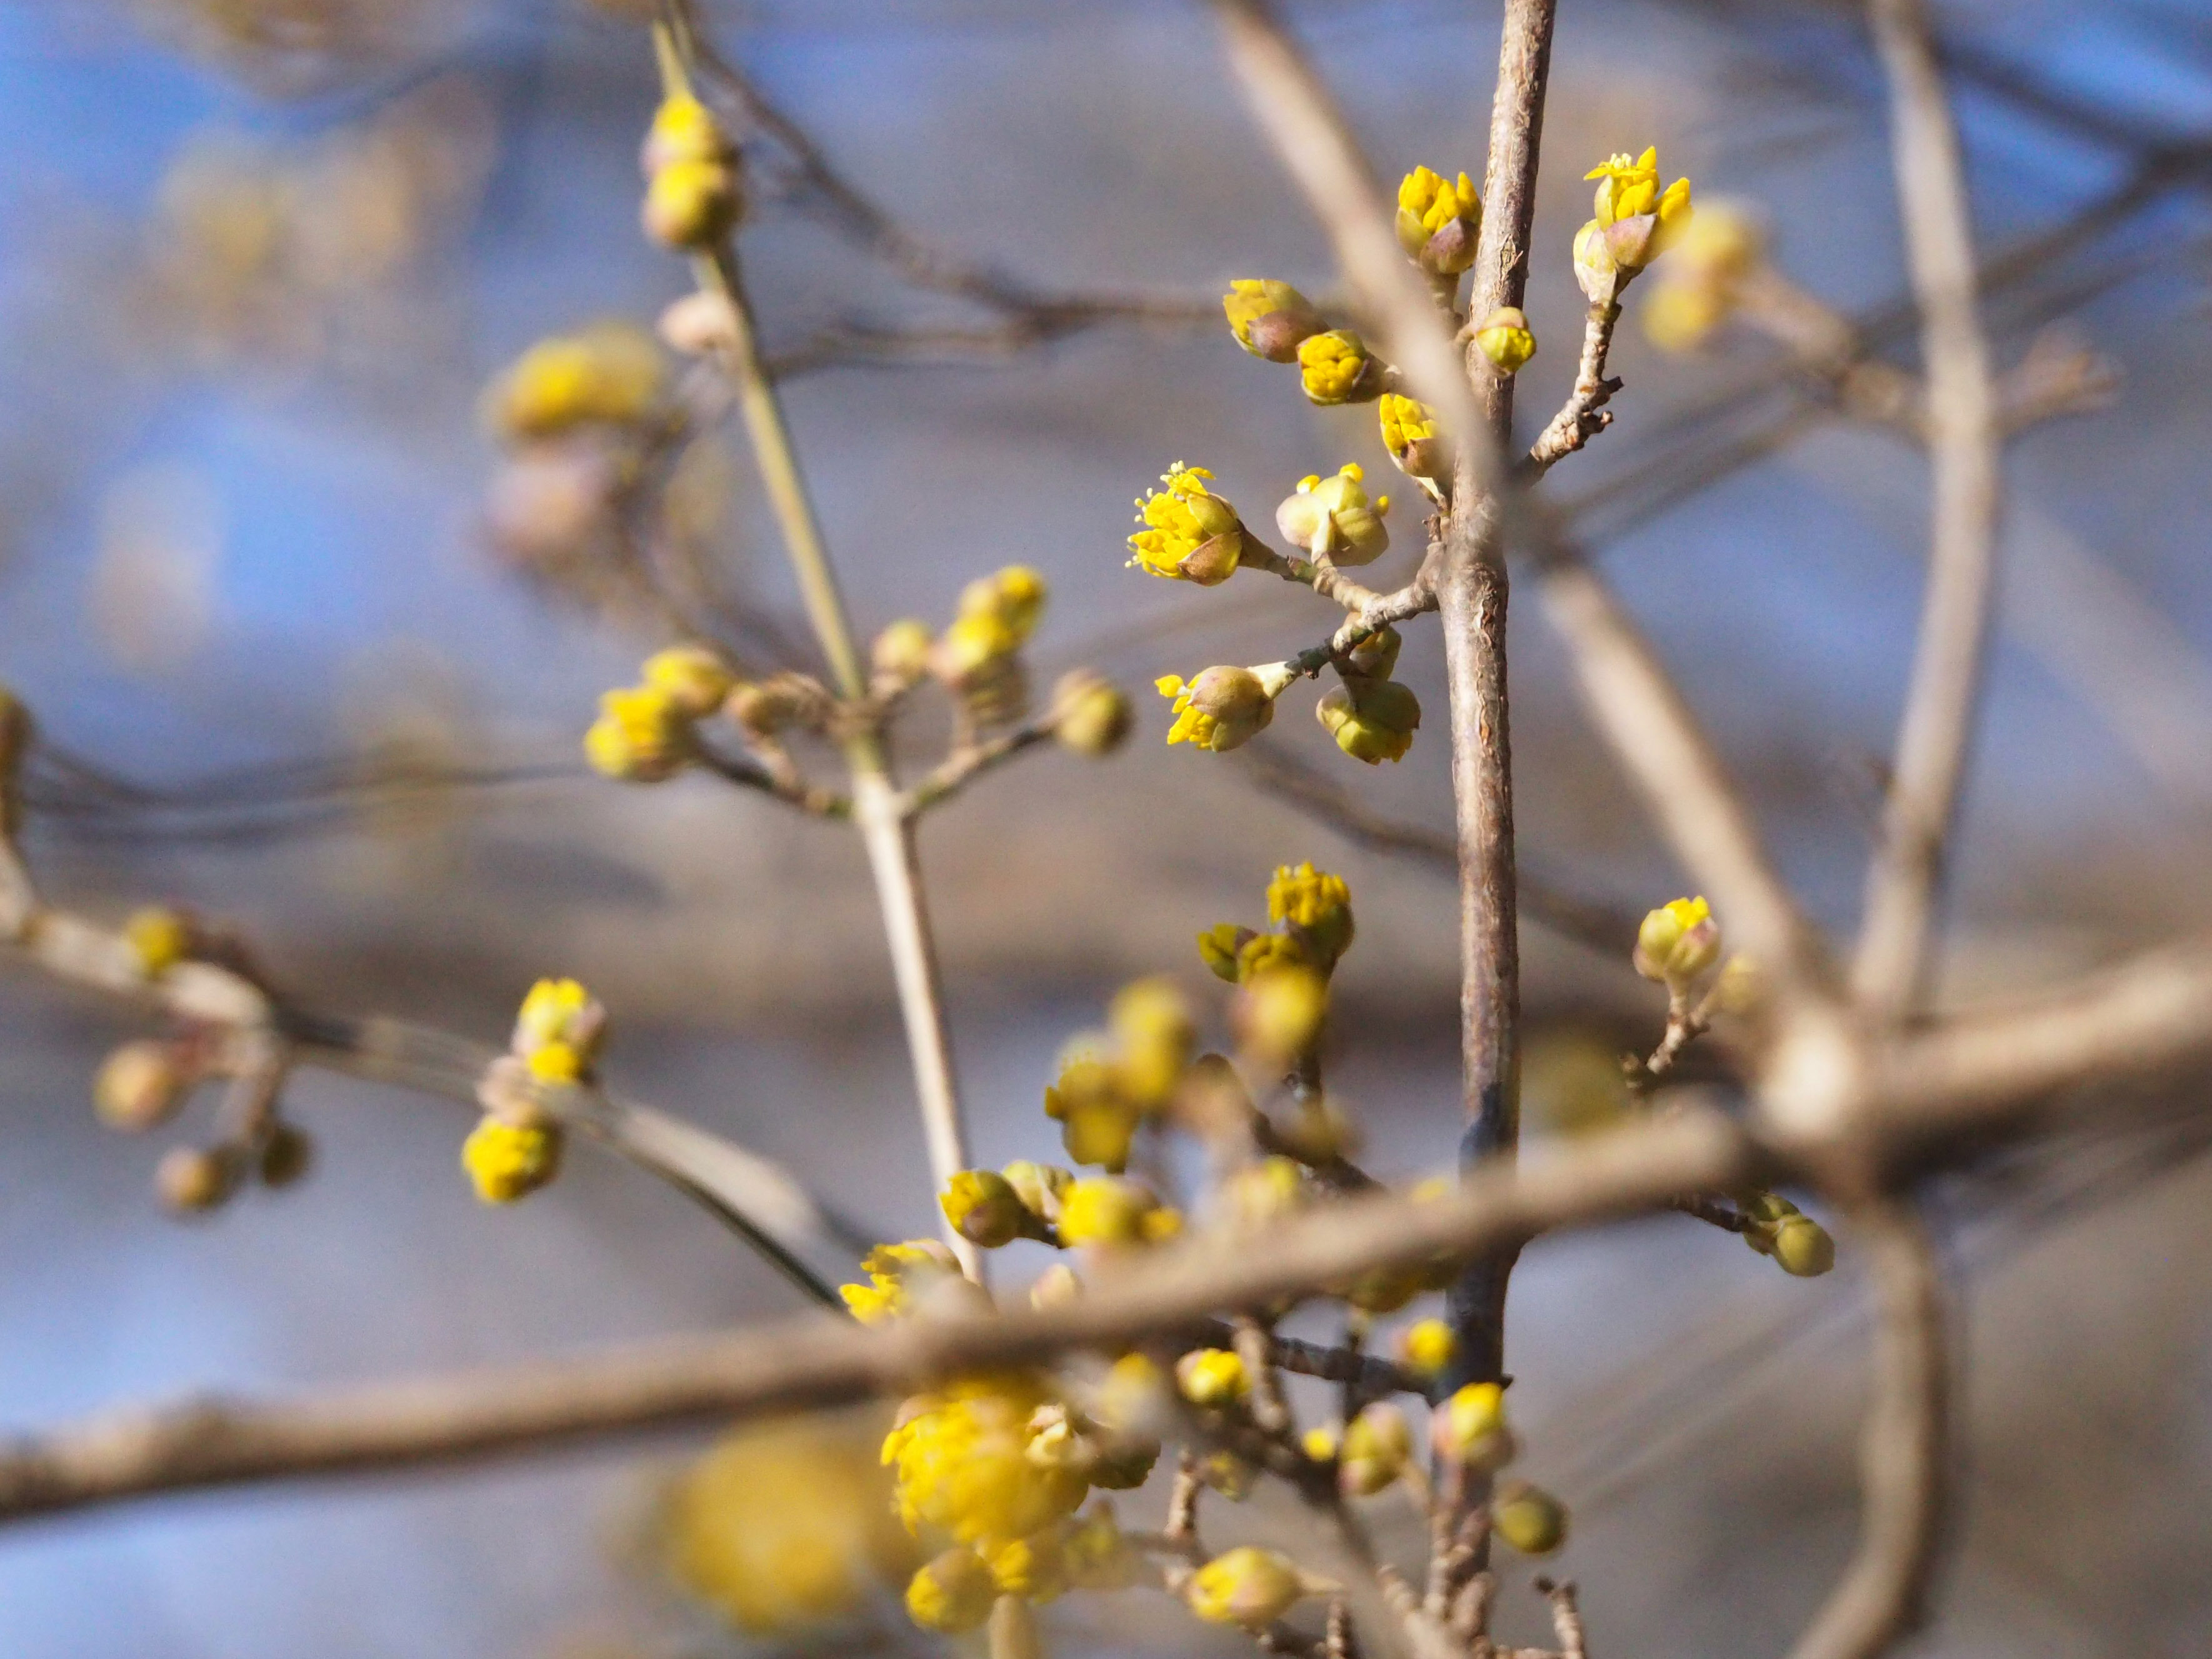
1789,1199,1951,1659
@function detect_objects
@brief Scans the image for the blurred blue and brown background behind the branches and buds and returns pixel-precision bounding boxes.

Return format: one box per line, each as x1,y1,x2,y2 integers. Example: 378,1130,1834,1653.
0,0,2212,1659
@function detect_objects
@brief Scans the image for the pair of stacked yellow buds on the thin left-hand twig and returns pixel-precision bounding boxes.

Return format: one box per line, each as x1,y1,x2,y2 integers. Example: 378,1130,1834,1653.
460,980,606,1203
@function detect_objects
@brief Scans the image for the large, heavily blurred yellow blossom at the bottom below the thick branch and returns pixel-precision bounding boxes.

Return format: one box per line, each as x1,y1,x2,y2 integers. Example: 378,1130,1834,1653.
661,1418,916,1635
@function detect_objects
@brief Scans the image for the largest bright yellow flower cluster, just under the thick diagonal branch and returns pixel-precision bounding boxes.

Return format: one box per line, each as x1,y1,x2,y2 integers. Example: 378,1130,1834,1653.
883,1374,1086,1548
